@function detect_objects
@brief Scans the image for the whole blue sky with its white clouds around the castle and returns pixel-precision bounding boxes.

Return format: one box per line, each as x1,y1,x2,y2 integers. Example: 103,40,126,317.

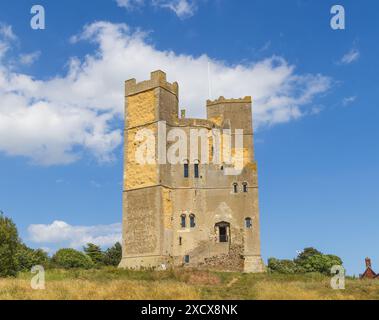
0,0,379,274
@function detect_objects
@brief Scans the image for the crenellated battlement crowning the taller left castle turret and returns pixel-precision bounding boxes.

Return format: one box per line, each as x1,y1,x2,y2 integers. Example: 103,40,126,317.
125,70,179,97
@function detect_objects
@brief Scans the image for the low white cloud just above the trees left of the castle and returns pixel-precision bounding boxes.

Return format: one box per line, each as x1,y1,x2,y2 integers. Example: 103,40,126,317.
28,221,122,248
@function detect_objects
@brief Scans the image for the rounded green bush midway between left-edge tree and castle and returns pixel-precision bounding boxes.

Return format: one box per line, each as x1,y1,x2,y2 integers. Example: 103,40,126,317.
51,248,93,269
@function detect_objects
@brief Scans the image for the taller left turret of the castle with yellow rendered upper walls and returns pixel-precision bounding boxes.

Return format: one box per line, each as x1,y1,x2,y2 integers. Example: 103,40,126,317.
120,70,179,268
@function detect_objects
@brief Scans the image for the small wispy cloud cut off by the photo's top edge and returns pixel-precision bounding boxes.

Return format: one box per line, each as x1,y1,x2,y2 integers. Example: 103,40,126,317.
116,0,197,19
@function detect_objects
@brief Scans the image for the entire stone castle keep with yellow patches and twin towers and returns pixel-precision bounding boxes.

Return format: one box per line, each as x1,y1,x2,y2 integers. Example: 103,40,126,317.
120,71,264,272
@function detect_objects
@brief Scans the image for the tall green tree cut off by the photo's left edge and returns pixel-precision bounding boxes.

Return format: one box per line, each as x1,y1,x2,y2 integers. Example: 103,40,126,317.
0,211,20,277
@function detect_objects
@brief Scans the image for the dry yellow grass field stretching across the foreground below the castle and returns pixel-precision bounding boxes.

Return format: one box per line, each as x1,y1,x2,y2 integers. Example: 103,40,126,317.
0,268,379,300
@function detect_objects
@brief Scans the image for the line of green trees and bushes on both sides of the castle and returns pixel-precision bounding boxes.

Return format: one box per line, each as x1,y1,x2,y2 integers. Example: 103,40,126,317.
0,211,342,277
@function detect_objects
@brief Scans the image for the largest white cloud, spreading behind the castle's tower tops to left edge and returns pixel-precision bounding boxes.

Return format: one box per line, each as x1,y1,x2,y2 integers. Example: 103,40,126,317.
0,22,331,165
